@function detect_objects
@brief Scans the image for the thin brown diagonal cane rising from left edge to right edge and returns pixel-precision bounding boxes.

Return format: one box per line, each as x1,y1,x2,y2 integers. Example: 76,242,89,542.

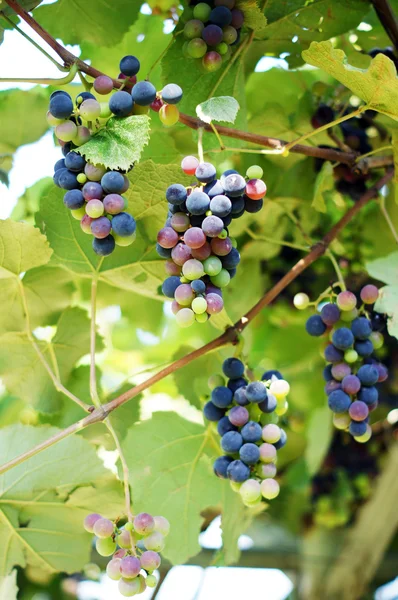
0,169,394,475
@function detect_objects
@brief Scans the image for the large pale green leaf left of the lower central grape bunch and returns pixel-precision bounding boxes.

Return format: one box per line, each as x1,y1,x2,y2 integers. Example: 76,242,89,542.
122,412,228,564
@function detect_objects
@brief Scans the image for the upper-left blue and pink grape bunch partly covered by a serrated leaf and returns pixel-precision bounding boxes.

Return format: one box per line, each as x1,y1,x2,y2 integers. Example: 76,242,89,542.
47,56,182,256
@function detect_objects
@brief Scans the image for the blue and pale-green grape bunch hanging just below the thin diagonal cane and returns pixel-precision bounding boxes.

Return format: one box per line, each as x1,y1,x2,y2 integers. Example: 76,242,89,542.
203,358,290,507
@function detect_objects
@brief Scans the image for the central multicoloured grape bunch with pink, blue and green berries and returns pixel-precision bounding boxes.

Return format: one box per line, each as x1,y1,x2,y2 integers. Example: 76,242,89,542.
157,156,267,327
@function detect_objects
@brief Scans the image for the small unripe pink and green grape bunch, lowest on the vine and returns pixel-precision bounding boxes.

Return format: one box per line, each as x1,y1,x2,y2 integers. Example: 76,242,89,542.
84,513,170,597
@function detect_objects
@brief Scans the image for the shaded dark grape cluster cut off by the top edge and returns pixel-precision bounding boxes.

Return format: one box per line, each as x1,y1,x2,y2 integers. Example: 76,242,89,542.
183,0,244,73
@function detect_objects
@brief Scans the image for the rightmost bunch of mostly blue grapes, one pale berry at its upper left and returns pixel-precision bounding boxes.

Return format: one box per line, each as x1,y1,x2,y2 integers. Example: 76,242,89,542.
294,285,388,442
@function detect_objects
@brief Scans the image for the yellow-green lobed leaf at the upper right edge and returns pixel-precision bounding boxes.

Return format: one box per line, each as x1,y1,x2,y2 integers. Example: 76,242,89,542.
303,42,398,120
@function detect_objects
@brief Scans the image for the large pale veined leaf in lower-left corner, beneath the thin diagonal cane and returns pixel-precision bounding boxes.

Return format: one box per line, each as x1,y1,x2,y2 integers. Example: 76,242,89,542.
0,425,123,576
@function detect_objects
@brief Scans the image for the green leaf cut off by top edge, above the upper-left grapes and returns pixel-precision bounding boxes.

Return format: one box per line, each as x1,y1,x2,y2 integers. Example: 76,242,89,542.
34,0,141,47
